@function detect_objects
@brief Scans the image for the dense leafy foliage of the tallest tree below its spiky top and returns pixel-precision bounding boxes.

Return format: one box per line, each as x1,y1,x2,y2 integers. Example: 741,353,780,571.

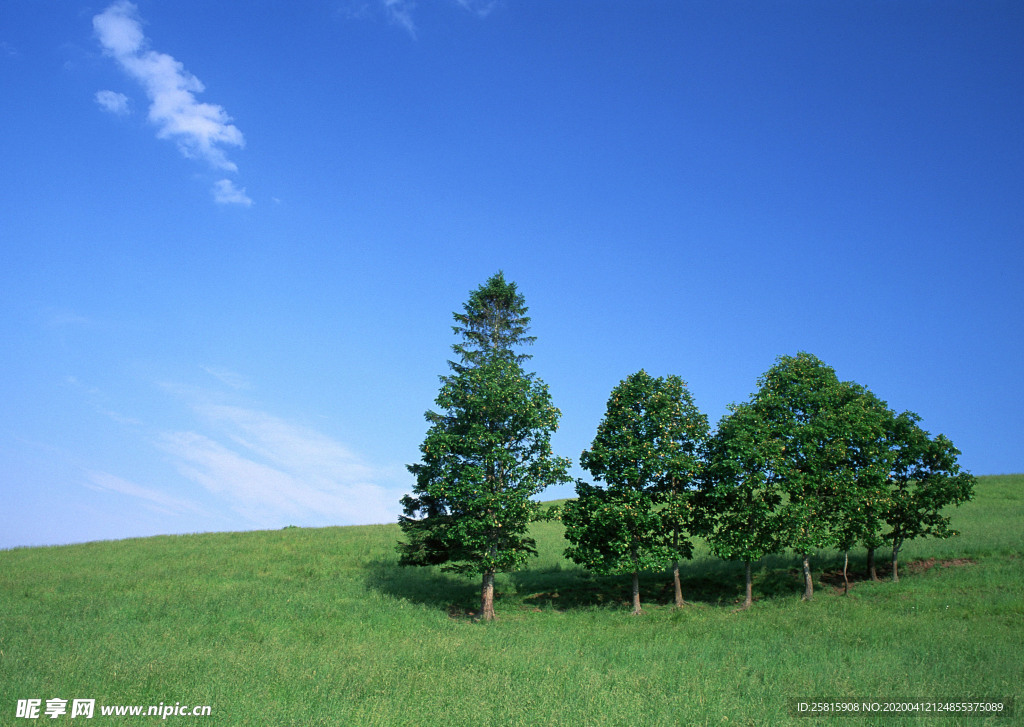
400,357,569,572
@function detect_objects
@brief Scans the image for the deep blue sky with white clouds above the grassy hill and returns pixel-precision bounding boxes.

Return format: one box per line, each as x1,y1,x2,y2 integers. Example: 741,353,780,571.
0,0,1024,547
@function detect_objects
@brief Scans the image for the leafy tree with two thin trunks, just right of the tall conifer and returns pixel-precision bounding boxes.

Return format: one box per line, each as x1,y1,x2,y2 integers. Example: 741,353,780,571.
562,371,708,613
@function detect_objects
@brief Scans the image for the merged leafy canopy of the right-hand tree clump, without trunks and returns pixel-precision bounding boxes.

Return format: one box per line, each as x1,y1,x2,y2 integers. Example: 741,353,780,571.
697,352,973,589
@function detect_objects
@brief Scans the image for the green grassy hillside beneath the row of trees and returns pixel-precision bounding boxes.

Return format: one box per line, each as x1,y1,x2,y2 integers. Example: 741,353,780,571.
0,475,1024,727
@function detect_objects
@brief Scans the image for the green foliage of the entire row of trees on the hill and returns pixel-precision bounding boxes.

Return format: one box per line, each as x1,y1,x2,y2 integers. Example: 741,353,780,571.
398,311,974,617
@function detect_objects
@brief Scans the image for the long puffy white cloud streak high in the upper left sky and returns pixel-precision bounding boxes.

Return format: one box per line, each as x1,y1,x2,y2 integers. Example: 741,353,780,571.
92,0,245,171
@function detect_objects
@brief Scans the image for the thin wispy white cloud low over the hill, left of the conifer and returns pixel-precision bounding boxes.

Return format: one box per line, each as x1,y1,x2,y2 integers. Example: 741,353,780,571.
66,367,409,529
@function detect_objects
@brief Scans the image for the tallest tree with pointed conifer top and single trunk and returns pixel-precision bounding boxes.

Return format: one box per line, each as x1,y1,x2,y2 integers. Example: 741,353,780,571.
398,272,569,621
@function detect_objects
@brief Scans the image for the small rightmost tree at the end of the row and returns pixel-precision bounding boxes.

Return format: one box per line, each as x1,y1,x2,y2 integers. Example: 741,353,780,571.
884,412,975,582
